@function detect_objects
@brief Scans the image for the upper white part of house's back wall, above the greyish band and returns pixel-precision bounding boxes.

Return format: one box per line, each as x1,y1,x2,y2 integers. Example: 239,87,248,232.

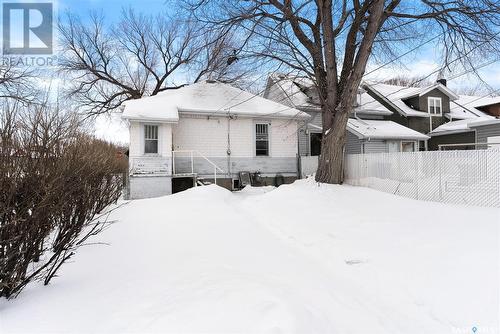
172,116,297,158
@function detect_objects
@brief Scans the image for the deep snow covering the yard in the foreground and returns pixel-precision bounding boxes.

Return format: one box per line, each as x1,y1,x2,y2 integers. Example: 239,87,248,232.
0,181,500,334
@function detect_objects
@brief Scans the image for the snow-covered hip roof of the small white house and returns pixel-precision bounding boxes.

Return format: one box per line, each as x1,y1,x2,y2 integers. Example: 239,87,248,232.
122,81,309,122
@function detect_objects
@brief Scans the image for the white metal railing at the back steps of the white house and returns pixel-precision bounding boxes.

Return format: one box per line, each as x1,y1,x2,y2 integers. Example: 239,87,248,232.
172,150,225,184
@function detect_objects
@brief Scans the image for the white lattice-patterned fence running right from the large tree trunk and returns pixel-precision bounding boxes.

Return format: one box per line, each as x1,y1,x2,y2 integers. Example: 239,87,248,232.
345,149,500,207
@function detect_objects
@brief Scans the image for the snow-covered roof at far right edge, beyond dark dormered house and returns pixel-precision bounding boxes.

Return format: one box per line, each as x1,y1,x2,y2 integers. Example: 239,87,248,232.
450,95,500,119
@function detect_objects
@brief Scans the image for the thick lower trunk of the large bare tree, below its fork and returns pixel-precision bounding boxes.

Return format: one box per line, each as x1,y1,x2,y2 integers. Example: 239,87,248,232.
316,110,349,184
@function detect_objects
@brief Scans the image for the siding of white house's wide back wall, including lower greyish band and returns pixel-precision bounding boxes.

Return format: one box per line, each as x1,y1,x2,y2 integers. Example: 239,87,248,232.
173,115,298,177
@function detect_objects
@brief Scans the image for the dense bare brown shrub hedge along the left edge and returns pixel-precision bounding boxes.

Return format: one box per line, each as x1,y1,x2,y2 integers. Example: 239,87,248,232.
0,104,125,298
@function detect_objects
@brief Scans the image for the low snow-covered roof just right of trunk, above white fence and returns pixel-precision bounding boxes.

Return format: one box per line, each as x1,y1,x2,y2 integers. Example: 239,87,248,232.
347,118,429,140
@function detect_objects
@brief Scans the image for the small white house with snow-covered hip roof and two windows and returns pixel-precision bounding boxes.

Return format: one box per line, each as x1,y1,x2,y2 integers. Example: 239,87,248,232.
122,81,309,198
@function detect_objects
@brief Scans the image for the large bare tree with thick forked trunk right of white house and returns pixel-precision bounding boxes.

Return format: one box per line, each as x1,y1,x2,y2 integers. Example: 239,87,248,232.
188,0,500,183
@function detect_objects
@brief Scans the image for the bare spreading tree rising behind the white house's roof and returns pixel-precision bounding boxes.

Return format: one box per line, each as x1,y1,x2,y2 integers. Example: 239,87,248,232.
59,9,248,115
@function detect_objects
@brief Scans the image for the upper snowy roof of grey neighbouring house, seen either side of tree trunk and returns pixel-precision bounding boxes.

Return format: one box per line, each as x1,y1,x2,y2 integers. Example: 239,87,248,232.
264,73,392,116
